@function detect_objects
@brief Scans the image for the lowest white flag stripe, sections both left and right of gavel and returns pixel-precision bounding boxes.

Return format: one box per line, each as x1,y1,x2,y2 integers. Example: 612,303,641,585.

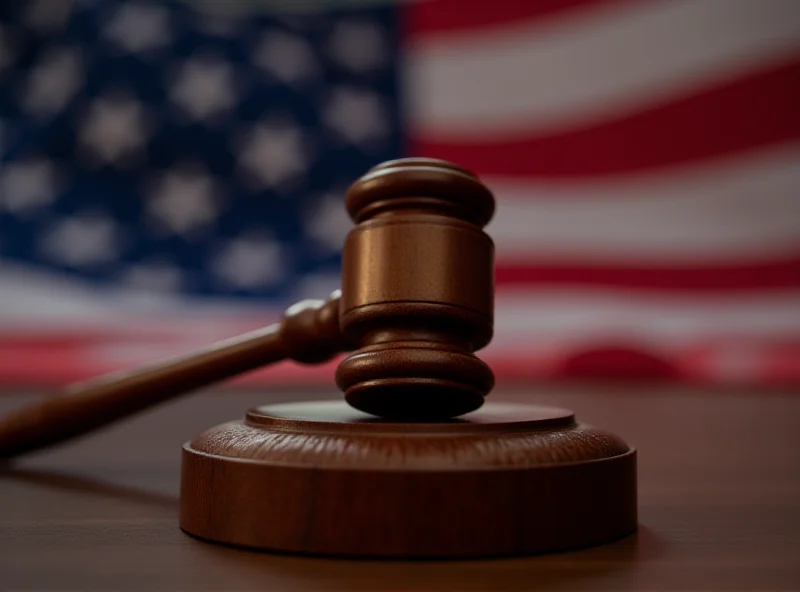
0,269,800,349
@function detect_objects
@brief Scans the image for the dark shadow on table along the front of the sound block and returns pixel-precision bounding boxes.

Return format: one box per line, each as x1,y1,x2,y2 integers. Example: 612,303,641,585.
184,526,666,592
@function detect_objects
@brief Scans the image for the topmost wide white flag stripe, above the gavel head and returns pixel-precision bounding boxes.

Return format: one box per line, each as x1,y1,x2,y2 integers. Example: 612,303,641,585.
406,0,800,139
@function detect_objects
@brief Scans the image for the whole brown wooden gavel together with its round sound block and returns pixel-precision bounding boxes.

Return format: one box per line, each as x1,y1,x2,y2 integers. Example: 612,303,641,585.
0,158,637,558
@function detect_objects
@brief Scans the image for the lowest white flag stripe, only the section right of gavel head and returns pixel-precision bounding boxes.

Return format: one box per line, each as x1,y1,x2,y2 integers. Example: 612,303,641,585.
490,289,800,347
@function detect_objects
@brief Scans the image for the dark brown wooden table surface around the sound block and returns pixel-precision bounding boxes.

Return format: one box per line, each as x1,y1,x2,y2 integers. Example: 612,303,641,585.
0,385,800,592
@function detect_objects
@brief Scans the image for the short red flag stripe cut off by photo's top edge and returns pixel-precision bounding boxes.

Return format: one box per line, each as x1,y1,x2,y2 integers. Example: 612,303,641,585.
404,0,631,40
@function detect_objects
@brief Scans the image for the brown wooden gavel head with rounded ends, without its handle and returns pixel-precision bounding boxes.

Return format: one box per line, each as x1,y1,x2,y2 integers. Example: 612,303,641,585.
336,158,494,420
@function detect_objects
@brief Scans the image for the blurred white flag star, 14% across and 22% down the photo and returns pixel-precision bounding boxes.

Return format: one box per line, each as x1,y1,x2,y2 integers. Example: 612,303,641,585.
80,96,147,164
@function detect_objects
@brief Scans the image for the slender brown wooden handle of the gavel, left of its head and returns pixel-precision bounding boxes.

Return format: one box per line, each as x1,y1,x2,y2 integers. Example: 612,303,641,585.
0,292,349,458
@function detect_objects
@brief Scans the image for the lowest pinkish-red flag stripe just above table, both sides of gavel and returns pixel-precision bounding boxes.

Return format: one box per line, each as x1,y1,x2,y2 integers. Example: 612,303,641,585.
0,342,800,388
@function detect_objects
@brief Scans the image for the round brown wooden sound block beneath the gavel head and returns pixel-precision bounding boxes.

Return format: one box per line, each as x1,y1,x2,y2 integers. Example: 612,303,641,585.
180,401,637,558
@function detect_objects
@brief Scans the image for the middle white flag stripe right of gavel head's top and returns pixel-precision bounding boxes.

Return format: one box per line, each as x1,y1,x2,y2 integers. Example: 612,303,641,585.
483,144,800,263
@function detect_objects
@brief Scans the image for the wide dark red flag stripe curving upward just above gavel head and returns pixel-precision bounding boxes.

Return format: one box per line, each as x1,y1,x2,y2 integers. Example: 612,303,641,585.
410,58,800,178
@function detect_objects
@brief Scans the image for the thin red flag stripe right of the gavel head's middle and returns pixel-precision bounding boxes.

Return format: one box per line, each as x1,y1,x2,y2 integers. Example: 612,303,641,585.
495,255,800,293
